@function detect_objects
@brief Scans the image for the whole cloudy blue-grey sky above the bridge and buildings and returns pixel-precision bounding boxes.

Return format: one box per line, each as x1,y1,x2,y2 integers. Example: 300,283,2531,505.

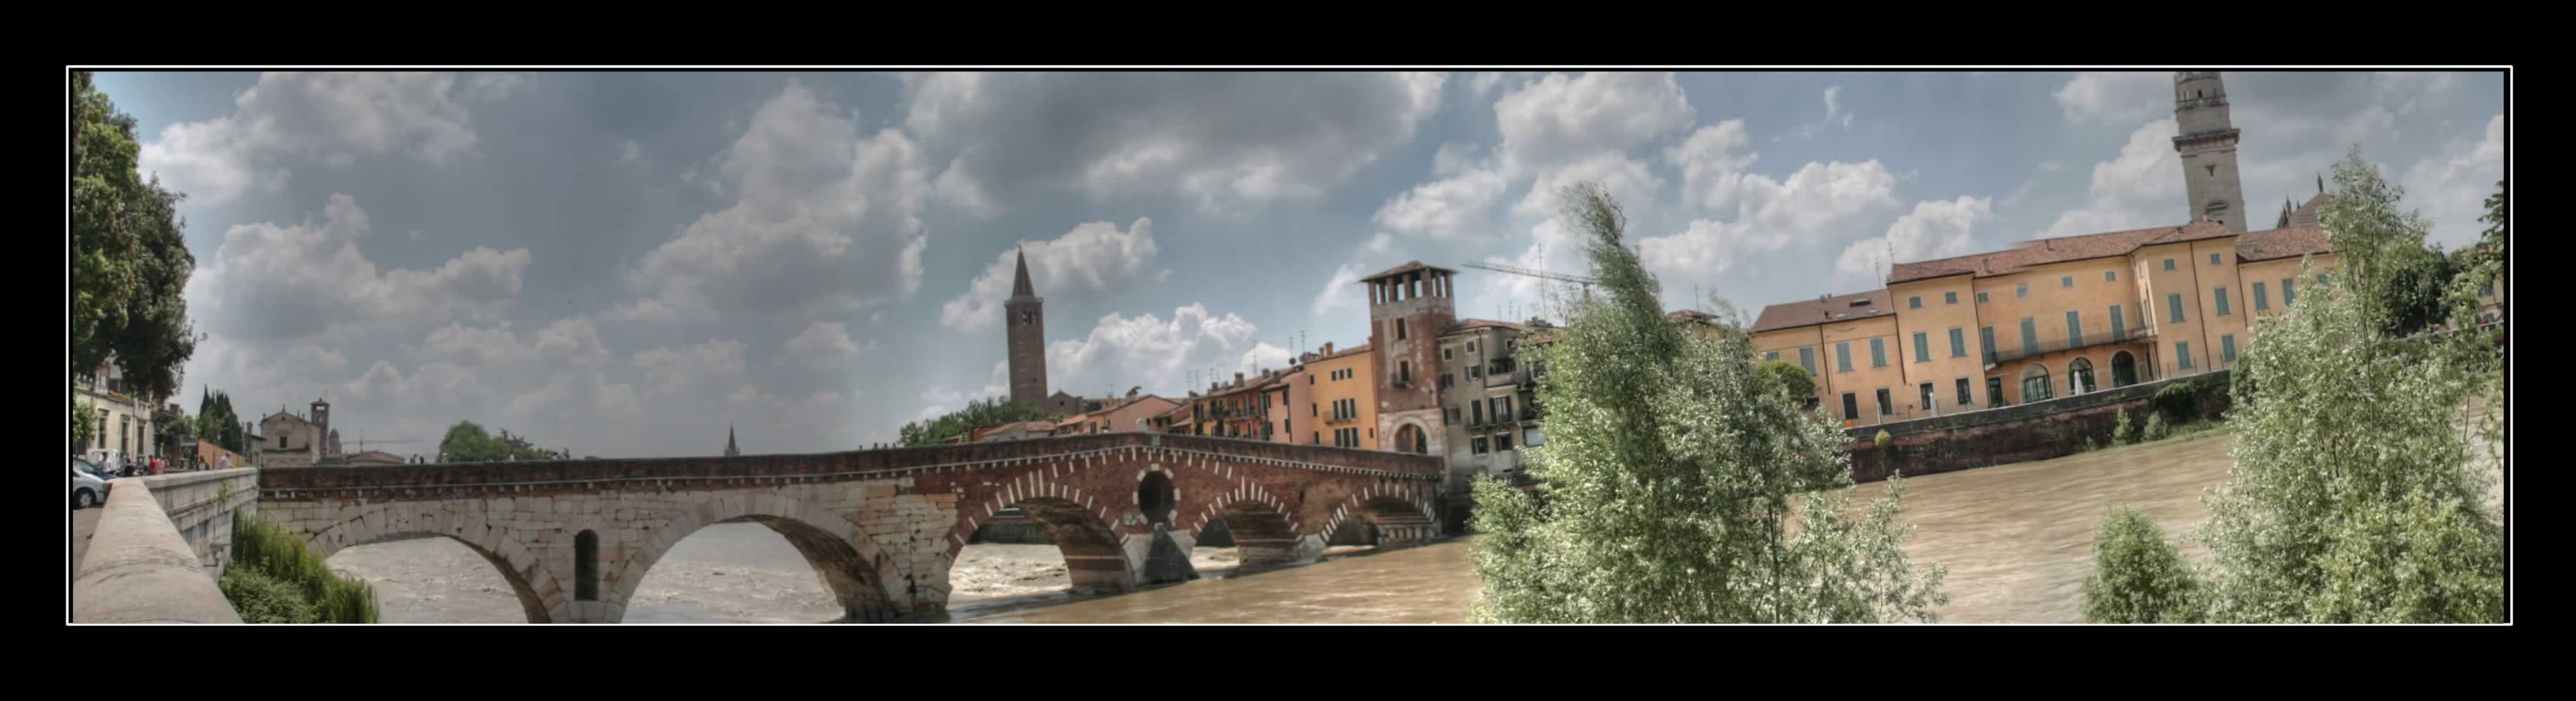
98,72,2504,456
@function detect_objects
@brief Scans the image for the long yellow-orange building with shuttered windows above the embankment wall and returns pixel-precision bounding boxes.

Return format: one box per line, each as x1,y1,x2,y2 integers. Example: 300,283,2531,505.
1752,219,2334,425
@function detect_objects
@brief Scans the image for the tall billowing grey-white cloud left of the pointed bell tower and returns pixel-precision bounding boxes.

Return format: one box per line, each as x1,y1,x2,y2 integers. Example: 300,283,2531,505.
613,82,930,320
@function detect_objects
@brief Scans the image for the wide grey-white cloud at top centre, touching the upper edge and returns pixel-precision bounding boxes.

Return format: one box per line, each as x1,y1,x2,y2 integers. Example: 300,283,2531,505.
904,72,1445,214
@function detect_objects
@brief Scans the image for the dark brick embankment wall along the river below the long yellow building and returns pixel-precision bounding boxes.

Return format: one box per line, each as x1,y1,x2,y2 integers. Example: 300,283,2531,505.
1847,371,2228,482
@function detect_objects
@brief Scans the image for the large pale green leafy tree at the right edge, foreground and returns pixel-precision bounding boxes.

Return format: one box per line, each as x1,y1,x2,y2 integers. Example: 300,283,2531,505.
2202,149,2504,624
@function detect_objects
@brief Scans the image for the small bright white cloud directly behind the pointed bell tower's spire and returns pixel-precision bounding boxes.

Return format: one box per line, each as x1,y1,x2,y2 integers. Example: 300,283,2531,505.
940,219,1172,330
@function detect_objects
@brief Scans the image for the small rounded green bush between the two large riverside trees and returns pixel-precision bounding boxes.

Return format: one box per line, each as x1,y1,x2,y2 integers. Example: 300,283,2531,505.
2082,505,2205,624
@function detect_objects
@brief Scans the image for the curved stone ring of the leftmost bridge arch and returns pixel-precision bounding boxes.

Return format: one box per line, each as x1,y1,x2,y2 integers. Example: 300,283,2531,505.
304,503,567,624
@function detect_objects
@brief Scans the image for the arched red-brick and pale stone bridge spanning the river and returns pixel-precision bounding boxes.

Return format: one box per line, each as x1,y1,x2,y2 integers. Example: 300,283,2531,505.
260,433,1440,624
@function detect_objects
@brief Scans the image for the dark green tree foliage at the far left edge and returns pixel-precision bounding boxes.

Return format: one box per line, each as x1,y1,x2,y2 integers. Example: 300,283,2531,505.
69,72,196,399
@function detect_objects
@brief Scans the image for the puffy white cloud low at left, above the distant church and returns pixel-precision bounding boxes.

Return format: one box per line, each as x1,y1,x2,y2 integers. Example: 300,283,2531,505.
185,193,528,343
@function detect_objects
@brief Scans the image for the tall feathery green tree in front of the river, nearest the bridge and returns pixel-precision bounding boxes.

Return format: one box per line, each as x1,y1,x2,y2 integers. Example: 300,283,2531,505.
1473,183,1948,624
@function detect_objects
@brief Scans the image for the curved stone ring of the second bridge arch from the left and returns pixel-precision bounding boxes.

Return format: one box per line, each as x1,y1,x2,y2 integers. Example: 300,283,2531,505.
615,495,914,624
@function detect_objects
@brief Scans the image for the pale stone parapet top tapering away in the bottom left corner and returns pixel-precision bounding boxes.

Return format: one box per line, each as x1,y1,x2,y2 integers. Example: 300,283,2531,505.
72,479,242,624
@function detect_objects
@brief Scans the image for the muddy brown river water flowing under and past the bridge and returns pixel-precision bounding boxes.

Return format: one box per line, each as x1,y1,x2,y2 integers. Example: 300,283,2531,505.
330,433,2502,624
